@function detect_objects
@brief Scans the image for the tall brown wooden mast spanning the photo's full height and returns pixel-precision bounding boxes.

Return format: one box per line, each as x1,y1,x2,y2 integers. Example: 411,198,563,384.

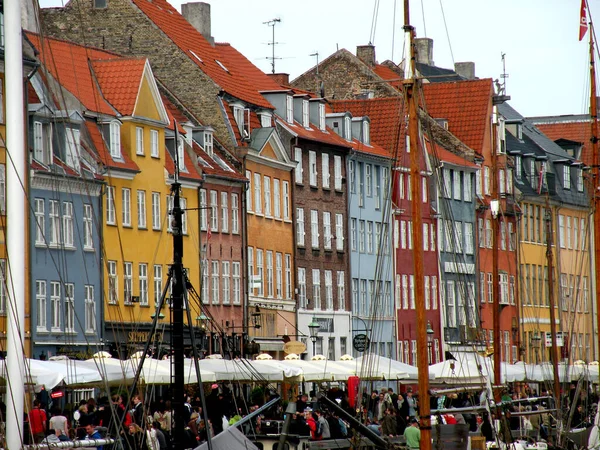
403,0,431,450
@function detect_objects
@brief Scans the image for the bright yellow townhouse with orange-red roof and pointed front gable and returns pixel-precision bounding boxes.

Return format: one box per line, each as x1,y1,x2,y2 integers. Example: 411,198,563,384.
32,36,201,356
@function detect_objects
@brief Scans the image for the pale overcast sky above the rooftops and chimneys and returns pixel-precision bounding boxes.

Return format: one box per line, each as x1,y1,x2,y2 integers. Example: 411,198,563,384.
40,0,600,116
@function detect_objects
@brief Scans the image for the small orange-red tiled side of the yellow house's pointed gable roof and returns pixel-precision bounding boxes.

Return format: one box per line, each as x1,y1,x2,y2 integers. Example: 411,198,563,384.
91,58,146,116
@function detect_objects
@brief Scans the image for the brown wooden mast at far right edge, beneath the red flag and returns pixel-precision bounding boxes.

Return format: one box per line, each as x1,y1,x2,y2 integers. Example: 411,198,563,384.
589,21,600,362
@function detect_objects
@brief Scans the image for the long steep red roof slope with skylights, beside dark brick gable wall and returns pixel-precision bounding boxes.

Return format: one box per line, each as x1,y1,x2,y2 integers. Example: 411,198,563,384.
132,0,272,108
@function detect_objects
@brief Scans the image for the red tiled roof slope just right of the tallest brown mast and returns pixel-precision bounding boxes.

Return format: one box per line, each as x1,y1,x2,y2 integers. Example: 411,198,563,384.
423,78,494,153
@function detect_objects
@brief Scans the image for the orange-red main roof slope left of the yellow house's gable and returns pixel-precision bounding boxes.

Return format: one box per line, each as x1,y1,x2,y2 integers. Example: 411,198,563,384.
27,32,116,115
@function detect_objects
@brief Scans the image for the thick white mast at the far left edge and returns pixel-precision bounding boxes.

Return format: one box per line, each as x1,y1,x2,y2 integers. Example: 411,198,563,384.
0,0,27,450
